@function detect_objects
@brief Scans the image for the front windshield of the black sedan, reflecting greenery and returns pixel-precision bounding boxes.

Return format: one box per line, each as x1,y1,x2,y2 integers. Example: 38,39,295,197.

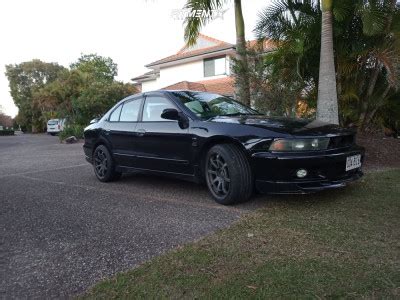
171,91,260,119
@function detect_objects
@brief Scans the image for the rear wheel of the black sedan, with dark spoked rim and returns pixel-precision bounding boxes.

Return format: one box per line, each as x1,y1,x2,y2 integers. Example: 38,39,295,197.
93,145,121,182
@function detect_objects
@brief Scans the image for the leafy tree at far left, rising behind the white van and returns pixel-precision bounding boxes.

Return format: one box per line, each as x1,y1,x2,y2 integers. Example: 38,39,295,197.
5,59,65,131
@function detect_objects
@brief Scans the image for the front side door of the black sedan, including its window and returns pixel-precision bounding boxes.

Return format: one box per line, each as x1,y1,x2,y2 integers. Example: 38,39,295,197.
135,94,193,174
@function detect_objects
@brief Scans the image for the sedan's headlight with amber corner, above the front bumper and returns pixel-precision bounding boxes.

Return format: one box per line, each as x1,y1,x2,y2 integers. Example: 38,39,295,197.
269,138,329,152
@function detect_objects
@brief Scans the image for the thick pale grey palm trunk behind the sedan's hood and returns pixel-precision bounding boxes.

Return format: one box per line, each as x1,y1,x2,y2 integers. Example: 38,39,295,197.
317,0,339,124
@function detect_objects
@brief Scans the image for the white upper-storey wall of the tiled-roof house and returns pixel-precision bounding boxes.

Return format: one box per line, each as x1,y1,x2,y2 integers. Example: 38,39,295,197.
142,56,230,92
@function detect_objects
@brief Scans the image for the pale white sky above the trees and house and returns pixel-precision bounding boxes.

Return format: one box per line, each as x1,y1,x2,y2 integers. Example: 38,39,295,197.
0,0,270,117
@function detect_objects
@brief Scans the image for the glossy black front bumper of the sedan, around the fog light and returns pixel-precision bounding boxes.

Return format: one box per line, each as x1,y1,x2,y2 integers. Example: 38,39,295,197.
252,146,364,194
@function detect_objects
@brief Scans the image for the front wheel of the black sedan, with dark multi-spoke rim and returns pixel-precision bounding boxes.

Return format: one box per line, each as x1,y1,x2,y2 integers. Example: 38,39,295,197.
204,144,254,205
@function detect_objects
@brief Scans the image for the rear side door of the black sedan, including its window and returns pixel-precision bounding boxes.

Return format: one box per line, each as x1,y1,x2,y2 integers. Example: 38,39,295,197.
105,97,143,167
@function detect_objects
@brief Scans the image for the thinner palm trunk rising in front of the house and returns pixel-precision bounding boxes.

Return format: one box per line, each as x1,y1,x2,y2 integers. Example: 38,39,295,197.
235,0,250,105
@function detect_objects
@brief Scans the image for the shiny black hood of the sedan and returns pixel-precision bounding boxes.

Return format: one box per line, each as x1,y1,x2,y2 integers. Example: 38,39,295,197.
209,115,352,136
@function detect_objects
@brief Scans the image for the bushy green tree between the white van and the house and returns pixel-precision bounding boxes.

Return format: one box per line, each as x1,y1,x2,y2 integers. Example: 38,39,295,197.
34,54,137,127
